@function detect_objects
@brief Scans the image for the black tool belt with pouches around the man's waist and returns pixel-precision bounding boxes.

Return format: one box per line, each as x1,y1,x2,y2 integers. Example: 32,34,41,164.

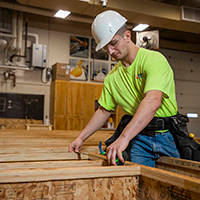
105,113,200,161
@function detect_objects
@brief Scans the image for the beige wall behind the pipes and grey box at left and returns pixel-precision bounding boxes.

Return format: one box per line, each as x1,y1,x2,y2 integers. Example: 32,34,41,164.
0,15,94,122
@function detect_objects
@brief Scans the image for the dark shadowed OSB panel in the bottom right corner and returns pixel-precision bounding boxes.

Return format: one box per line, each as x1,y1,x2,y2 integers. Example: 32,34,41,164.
138,176,200,200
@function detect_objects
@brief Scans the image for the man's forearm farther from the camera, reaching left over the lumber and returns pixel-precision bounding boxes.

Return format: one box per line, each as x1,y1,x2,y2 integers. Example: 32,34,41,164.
78,107,111,141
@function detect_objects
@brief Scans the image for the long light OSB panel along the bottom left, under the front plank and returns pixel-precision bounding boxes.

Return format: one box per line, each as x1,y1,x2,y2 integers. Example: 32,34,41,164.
0,176,138,200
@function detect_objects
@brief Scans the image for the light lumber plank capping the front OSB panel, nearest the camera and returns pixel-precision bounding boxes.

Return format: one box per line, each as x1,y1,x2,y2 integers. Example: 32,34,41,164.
0,166,140,183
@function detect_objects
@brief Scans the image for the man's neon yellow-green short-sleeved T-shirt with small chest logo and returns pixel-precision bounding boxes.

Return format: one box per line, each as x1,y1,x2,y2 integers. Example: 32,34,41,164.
98,48,177,117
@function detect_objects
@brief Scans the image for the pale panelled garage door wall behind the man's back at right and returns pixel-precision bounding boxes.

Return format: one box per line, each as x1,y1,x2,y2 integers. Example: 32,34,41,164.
160,49,200,137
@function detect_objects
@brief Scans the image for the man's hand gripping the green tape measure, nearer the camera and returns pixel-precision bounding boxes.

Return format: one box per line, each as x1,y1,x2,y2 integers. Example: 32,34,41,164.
106,136,129,165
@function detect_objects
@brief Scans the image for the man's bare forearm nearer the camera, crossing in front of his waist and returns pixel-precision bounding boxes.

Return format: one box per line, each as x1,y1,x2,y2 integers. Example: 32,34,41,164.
120,90,161,141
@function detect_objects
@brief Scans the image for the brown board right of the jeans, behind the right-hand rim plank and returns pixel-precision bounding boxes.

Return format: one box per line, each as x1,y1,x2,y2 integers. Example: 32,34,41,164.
156,157,200,179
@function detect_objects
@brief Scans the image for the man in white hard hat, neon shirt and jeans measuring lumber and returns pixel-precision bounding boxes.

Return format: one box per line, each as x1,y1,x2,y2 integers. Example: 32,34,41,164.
69,11,180,167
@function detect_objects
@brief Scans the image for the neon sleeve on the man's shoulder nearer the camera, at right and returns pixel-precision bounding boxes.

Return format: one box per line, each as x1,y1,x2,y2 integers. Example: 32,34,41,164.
144,53,174,98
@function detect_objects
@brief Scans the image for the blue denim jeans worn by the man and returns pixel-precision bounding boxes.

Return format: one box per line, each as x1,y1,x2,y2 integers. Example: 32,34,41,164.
130,132,180,167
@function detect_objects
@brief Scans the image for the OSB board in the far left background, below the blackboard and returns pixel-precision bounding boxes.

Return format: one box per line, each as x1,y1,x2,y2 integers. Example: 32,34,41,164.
0,118,42,130
